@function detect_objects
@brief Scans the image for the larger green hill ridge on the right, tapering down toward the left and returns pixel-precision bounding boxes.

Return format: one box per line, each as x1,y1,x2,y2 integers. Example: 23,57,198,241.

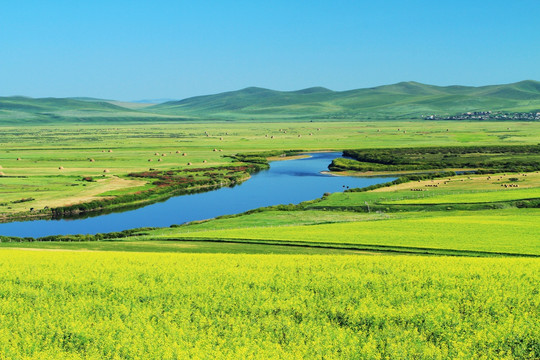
148,81,540,119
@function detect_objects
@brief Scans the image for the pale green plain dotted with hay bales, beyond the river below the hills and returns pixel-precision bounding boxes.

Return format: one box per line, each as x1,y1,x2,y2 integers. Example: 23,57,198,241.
0,121,540,219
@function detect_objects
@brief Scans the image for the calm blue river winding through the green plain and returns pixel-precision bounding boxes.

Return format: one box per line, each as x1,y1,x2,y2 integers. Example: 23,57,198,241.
0,153,392,237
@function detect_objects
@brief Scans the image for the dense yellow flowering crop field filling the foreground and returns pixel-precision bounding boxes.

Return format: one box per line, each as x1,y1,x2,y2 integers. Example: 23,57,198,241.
0,250,540,359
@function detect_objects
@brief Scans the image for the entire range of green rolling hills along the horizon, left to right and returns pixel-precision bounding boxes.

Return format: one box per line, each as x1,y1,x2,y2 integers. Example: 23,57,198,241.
0,80,540,124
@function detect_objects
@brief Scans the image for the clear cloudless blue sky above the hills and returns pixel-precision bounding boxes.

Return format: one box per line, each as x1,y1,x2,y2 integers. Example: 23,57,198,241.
0,0,540,100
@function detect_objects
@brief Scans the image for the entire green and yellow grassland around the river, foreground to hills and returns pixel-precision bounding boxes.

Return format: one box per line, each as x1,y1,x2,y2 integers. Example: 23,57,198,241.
0,121,540,359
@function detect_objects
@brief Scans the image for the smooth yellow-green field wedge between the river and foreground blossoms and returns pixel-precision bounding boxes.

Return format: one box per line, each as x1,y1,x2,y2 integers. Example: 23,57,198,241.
144,209,540,255
